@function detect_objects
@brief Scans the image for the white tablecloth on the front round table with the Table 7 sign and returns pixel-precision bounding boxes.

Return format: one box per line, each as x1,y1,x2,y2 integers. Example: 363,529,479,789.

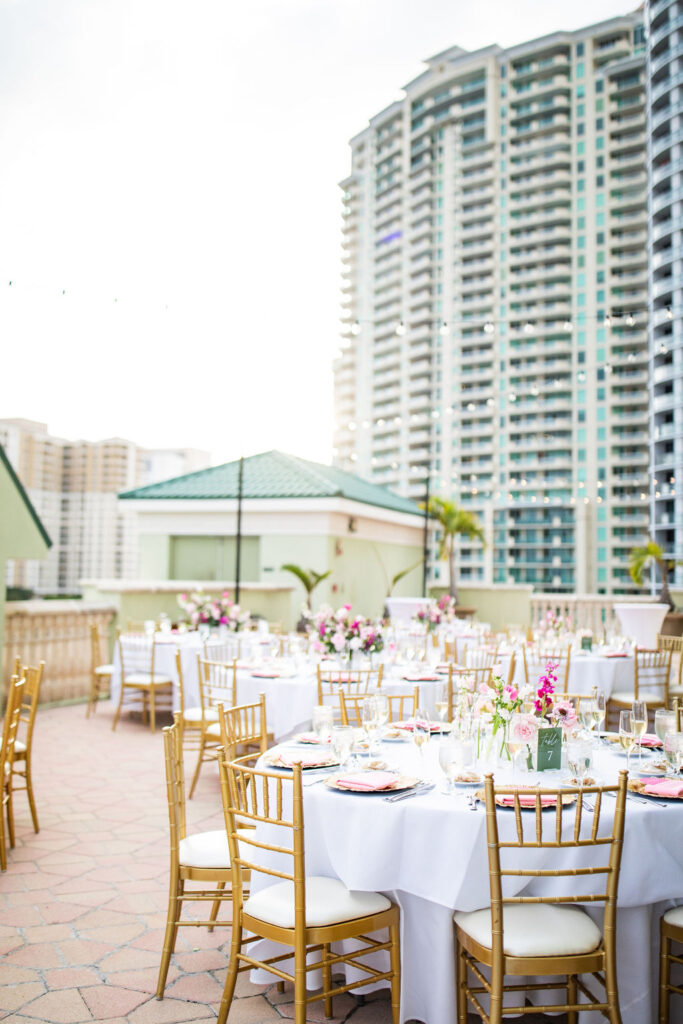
252,741,683,1024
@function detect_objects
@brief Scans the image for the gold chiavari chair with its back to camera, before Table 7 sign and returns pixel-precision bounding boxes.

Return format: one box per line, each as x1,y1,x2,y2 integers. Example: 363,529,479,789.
455,771,627,1024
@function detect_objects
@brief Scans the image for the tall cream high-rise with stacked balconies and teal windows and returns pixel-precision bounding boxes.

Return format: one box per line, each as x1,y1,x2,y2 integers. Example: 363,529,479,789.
335,12,649,593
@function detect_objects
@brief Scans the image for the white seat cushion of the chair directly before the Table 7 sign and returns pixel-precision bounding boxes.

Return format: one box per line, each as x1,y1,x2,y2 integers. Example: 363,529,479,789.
454,903,602,956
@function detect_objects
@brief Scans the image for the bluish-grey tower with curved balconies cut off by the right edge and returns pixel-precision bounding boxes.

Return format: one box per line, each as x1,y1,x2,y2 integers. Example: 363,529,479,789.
647,0,683,587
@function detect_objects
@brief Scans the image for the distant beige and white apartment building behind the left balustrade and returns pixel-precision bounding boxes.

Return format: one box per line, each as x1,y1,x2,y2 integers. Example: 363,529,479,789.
0,419,209,594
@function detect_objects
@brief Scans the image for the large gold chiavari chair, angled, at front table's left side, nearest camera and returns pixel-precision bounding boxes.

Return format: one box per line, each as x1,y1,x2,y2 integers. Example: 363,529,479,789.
218,758,400,1024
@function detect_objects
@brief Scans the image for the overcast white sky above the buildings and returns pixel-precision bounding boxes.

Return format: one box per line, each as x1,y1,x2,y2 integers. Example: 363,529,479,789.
0,0,635,462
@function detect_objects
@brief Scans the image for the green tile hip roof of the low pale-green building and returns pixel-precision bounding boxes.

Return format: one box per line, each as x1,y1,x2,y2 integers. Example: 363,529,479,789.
119,452,422,515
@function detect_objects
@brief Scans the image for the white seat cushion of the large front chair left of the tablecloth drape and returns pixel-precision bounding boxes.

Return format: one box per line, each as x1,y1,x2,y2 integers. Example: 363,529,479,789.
244,876,391,928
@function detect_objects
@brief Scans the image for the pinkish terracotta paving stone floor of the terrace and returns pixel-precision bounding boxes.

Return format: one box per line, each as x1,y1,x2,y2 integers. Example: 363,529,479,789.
0,705,558,1024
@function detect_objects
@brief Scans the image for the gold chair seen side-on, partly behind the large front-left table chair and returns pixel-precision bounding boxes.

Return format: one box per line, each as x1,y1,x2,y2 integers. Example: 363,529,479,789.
157,712,252,999
